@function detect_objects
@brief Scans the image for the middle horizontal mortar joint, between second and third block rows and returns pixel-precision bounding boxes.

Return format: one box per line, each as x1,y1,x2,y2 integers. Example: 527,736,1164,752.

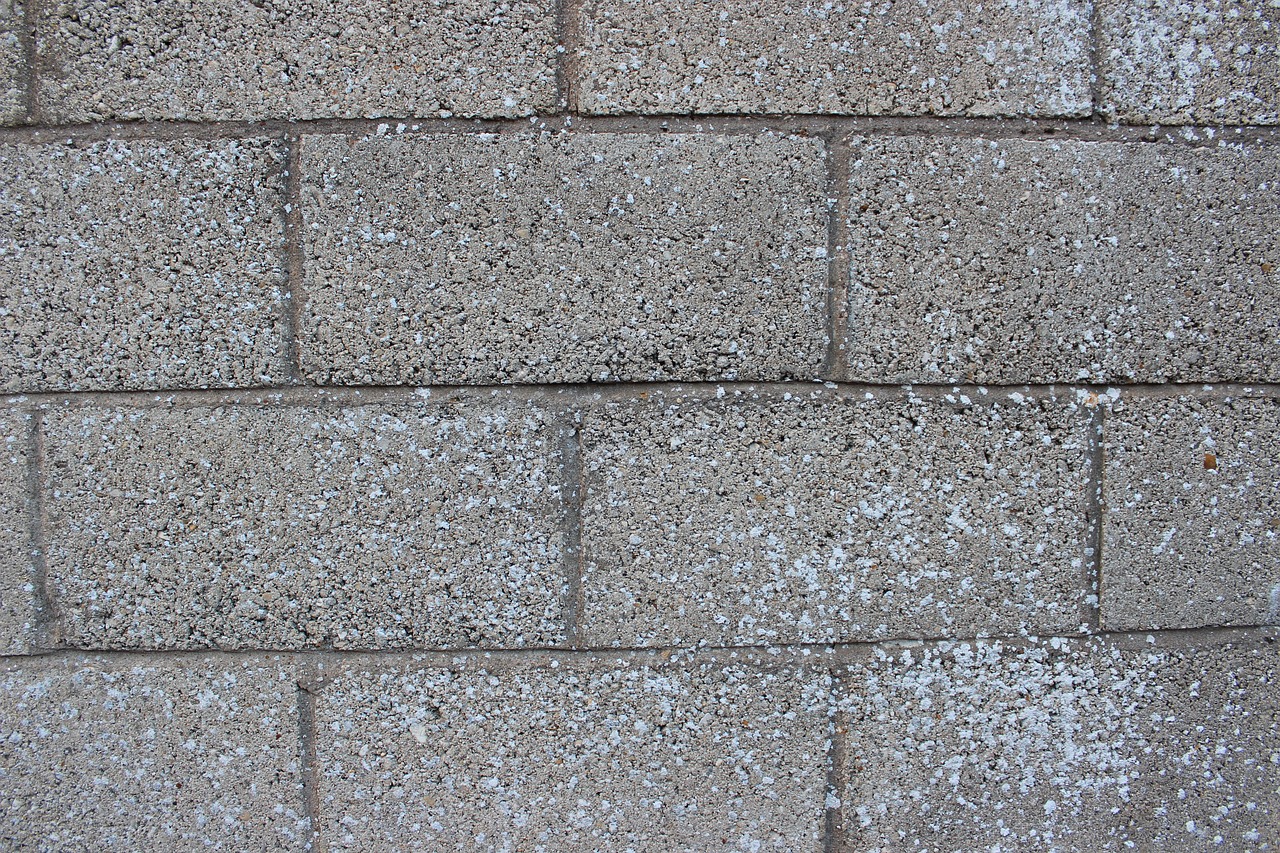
10,379,1280,407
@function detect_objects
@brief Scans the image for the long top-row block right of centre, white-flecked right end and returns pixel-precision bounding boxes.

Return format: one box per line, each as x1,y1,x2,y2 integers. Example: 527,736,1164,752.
576,0,1092,115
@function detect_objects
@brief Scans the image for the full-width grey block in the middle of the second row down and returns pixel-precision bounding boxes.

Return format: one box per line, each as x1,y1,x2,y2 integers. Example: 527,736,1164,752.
298,132,827,384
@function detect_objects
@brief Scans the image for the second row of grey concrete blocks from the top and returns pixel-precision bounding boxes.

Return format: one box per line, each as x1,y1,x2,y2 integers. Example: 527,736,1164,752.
0,130,1280,392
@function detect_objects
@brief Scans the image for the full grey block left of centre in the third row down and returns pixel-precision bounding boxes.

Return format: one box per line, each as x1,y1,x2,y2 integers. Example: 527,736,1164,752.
44,394,564,649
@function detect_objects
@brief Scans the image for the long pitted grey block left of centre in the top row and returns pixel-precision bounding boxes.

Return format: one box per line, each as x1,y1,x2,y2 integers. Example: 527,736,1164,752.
36,0,557,122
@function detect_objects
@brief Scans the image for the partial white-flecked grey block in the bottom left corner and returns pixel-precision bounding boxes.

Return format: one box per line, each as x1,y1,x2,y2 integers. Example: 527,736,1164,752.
0,656,308,850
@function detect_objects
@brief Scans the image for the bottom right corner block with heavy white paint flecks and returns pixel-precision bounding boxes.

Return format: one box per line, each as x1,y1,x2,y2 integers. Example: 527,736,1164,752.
837,638,1280,853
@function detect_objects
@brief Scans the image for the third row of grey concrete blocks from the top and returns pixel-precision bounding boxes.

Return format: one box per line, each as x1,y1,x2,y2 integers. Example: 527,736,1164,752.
0,384,1280,652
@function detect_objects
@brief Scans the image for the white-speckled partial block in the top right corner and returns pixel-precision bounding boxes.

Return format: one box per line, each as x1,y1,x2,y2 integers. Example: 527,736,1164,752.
1098,0,1280,124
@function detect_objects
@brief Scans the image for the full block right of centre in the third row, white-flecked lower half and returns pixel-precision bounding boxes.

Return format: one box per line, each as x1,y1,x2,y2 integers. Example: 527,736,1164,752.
581,391,1088,647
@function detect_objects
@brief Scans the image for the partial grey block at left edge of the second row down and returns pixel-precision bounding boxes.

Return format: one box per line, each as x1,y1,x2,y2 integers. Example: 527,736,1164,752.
0,138,288,391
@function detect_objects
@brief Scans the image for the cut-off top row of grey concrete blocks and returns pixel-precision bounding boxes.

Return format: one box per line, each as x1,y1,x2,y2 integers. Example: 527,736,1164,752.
0,0,1280,124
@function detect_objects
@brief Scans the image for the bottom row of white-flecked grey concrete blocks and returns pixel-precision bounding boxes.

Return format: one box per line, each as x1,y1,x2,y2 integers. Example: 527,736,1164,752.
0,640,1280,853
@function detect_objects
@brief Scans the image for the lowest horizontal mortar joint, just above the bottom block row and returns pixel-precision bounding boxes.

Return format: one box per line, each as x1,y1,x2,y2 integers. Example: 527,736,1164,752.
0,624,1280,665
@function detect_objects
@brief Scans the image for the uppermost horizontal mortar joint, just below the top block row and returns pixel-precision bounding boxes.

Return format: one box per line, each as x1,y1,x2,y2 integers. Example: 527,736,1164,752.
0,113,1280,145
